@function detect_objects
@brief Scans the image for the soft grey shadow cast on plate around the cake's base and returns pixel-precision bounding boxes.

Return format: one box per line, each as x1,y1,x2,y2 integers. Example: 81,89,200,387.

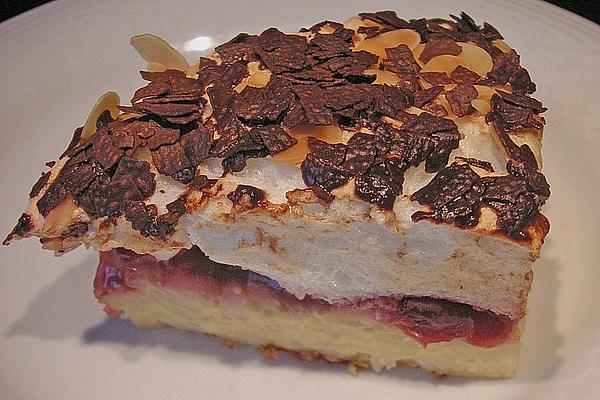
6,242,563,386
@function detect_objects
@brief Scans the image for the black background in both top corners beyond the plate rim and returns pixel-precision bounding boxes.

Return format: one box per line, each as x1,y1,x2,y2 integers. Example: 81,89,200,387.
0,0,600,24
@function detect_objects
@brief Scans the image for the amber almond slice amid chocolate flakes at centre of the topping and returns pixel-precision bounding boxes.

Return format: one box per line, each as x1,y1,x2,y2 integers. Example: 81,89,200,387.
273,125,343,165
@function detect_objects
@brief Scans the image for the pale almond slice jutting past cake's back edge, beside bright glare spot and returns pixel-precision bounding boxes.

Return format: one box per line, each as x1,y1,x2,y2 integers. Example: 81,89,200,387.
129,33,190,71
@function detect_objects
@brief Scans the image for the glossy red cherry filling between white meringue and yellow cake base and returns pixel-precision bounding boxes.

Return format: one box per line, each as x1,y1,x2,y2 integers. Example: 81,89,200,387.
94,246,518,347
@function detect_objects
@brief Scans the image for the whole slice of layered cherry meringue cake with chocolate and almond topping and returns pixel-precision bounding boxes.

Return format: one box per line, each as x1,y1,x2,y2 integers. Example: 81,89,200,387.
4,11,550,377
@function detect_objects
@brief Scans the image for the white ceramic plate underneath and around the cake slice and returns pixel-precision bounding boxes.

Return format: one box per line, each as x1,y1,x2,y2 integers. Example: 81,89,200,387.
0,0,600,400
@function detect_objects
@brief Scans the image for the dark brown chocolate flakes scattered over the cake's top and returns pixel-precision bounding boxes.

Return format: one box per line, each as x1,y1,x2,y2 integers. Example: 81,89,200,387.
12,11,550,244
